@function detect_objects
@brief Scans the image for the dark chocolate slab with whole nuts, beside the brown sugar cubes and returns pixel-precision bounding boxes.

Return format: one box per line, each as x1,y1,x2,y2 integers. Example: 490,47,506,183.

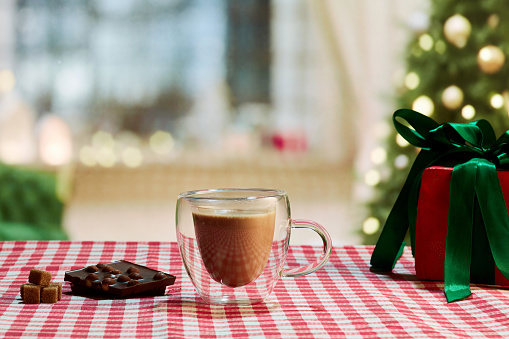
64,260,175,298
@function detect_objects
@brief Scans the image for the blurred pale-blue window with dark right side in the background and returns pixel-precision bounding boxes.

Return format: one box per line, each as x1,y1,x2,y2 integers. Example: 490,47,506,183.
15,0,270,133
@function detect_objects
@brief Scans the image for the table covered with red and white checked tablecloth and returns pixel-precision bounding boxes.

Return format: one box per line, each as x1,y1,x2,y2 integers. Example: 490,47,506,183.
0,241,509,338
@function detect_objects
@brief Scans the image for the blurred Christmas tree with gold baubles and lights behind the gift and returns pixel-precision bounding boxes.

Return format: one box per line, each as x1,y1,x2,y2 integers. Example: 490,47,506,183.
362,0,509,244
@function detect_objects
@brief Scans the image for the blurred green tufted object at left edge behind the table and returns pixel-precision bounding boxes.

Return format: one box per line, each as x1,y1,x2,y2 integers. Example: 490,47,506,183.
0,164,68,241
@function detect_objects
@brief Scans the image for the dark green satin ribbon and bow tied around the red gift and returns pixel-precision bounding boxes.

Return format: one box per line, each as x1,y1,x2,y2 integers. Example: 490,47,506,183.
371,109,509,302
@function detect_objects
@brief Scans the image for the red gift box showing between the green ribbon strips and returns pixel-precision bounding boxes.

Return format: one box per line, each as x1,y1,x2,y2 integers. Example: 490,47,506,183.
414,166,509,286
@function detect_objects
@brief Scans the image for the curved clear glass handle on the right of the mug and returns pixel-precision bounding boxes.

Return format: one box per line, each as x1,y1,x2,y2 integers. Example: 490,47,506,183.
281,219,332,277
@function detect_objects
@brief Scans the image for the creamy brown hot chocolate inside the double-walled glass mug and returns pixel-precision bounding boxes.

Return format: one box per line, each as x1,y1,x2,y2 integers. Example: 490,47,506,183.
193,211,276,287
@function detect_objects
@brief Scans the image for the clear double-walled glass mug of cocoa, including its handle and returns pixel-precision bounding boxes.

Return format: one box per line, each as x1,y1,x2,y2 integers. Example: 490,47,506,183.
176,189,332,304
